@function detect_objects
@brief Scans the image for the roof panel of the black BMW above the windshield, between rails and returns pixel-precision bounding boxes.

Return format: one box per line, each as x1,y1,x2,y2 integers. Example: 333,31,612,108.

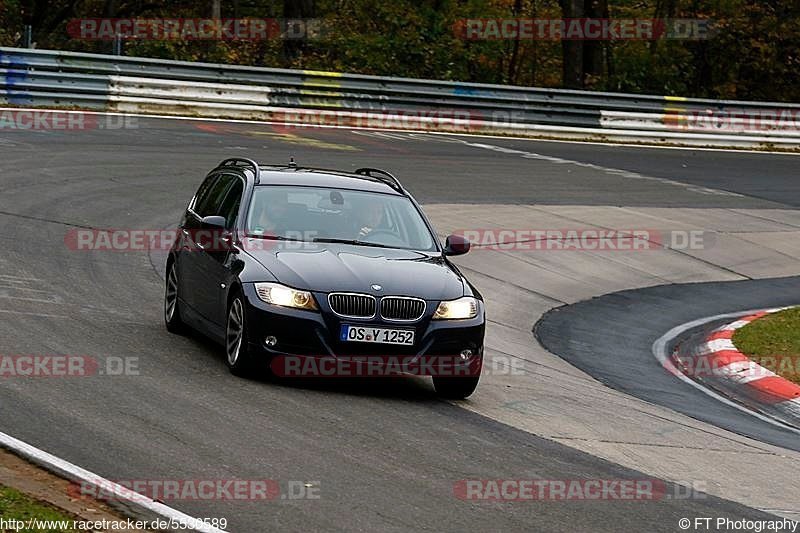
257,165,403,196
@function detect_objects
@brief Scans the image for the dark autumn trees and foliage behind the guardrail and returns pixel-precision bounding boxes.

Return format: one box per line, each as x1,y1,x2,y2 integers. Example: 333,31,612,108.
0,0,800,102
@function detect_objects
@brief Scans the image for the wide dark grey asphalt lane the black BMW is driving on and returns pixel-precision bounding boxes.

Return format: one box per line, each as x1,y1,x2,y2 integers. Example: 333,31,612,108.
0,119,794,532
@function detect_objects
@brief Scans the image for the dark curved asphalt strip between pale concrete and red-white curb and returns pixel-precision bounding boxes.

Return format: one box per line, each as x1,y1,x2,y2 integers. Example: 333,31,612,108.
535,277,800,451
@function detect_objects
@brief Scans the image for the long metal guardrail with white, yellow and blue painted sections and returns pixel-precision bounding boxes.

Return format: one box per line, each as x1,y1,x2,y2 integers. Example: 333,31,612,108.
0,48,800,149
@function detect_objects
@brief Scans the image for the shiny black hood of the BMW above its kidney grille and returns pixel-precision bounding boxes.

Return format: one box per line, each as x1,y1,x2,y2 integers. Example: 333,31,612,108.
248,240,464,300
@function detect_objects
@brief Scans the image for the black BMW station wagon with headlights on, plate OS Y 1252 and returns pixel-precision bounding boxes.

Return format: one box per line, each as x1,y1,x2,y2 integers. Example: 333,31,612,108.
164,158,485,398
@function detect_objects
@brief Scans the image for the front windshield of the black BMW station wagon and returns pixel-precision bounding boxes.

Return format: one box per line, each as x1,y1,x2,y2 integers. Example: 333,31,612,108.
247,185,436,251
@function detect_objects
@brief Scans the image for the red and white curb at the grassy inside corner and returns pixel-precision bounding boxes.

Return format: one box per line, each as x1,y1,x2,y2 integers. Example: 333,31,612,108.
671,309,800,427
